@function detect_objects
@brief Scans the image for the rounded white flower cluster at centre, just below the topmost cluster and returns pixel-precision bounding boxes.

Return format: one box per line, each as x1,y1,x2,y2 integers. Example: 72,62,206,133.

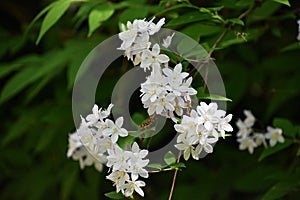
141,63,197,122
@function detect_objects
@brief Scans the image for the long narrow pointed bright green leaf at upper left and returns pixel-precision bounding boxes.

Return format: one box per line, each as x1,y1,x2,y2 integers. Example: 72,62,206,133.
36,0,71,44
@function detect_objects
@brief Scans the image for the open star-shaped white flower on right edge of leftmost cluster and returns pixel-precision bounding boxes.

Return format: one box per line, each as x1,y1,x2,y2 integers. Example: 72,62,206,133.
102,117,128,143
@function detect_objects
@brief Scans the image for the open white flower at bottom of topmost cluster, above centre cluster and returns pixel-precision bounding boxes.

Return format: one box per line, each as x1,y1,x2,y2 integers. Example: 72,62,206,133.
140,44,170,71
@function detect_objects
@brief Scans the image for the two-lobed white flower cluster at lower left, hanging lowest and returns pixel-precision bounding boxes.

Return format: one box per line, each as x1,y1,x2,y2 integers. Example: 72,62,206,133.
67,104,149,197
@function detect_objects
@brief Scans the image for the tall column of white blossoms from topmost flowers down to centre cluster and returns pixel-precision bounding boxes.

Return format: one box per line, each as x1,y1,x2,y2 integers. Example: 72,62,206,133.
119,19,197,122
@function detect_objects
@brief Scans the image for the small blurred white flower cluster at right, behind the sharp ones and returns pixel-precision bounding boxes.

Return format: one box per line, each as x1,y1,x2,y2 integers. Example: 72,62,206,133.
236,110,284,154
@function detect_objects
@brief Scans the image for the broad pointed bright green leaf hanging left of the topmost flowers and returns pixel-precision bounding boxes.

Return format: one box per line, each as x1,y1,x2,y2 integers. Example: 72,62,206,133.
88,5,115,37
